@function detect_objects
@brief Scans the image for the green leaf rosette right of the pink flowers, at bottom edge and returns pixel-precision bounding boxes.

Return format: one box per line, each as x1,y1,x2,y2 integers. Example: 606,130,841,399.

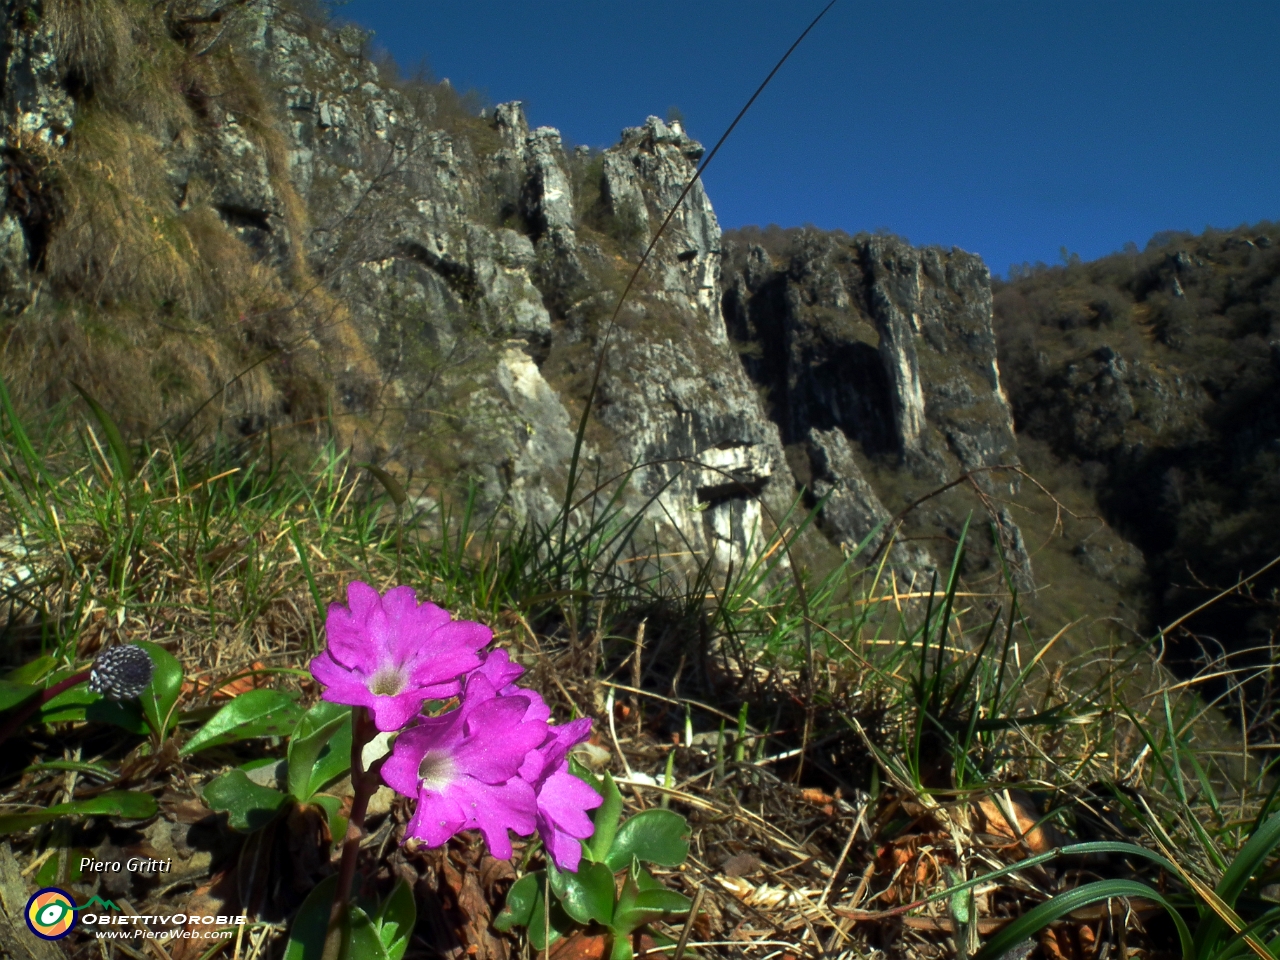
493,763,691,960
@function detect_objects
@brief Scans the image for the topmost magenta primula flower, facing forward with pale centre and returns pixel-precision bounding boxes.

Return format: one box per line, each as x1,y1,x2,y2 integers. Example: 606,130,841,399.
311,580,493,731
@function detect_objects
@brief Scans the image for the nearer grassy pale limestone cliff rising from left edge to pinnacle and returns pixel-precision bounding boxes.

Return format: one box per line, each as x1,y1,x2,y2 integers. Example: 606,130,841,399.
0,0,795,576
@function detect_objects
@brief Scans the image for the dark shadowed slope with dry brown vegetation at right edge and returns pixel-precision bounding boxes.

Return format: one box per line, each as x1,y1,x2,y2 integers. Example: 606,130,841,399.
995,223,1280,716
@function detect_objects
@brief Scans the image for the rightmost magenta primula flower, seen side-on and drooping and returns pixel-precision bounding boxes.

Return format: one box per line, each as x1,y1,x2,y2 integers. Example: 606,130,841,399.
520,717,604,873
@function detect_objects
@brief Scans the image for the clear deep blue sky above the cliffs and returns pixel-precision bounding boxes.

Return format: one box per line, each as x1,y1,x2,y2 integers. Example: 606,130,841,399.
335,0,1280,274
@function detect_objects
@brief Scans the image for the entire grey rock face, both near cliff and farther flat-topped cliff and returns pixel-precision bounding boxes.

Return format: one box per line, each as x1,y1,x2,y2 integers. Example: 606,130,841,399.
0,0,1029,586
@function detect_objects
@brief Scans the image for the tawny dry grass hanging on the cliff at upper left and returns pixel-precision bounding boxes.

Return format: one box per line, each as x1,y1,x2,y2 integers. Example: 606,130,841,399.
0,0,379,454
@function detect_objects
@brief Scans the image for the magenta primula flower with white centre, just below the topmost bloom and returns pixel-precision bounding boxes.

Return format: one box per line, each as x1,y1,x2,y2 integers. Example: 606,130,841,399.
381,672,547,859
